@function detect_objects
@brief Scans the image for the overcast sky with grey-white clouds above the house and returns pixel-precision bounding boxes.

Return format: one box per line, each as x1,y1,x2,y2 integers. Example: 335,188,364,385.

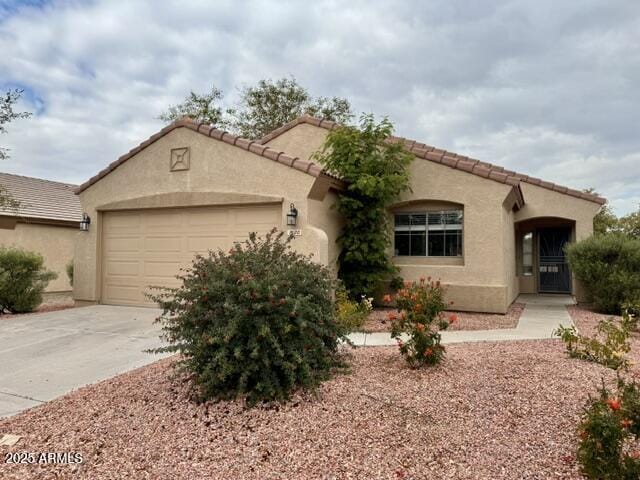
0,0,640,214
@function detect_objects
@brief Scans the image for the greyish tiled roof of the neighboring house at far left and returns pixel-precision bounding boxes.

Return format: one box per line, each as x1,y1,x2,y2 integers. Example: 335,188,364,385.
0,173,82,222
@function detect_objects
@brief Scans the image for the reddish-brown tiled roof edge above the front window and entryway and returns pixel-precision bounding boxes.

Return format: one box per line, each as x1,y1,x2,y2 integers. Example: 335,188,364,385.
259,115,606,205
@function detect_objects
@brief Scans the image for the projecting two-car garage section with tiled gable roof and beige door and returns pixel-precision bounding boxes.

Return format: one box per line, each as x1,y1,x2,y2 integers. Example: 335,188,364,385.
73,118,344,306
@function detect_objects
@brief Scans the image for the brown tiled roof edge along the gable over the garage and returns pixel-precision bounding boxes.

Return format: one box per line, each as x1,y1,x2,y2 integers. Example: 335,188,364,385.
75,117,342,193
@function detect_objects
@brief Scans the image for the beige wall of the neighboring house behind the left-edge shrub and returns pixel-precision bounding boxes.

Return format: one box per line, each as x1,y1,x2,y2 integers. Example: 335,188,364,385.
0,223,79,292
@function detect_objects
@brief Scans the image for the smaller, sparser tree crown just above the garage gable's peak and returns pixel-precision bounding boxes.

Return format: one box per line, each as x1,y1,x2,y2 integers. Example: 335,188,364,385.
158,85,233,128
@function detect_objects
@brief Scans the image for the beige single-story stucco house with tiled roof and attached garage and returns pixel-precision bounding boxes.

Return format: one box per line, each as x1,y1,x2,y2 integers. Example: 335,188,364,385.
74,116,604,312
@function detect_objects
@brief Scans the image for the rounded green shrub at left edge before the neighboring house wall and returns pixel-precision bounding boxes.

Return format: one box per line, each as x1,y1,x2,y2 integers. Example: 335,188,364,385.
0,247,57,313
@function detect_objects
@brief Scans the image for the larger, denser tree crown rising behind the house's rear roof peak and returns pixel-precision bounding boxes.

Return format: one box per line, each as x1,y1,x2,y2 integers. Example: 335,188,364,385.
234,77,353,138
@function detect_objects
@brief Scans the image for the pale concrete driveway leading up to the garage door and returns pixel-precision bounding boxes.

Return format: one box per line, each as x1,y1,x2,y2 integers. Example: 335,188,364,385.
0,305,166,418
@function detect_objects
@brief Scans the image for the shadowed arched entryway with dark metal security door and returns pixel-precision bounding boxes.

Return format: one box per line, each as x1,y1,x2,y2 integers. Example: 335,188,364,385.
515,217,575,294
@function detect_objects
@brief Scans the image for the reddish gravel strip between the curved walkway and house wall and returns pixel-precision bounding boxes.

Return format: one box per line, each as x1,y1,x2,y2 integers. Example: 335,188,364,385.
361,303,524,333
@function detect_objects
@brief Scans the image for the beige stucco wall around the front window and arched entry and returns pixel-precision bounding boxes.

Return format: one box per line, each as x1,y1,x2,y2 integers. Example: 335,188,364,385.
268,124,600,312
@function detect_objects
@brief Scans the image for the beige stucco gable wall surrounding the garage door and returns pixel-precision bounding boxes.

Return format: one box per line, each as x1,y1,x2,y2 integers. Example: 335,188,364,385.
74,128,329,301
